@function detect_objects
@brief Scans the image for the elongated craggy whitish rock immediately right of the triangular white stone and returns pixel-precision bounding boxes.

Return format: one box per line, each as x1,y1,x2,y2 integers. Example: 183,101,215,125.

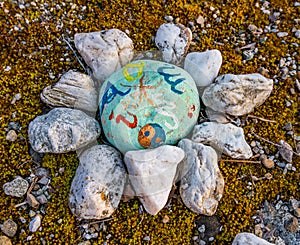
178,139,224,216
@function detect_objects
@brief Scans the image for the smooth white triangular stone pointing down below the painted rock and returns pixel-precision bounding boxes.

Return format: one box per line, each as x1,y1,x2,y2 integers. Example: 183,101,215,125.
124,145,185,215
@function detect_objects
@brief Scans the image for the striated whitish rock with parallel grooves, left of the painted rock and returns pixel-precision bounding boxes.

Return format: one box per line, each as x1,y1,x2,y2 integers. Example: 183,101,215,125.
41,70,98,112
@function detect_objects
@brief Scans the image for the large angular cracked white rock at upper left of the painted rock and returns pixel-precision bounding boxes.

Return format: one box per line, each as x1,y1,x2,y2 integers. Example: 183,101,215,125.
74,29,133,81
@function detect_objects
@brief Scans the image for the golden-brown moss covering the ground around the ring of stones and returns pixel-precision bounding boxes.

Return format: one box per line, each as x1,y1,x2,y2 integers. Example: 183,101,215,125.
0,0,300,244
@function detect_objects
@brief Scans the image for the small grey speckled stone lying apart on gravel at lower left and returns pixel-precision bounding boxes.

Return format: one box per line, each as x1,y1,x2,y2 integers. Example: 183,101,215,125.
3,176,29,197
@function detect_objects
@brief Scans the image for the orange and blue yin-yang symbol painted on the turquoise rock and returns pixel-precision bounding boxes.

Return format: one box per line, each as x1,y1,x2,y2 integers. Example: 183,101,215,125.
138,123,166,148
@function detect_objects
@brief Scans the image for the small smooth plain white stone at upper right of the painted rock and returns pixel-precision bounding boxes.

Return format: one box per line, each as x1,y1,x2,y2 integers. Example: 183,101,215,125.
184,49,222,87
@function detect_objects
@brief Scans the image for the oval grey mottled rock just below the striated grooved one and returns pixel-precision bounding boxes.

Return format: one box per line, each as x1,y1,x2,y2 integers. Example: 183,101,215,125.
28,108,100,153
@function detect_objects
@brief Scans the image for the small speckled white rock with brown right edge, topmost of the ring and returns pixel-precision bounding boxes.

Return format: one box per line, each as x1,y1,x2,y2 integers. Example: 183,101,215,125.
155,23,192,63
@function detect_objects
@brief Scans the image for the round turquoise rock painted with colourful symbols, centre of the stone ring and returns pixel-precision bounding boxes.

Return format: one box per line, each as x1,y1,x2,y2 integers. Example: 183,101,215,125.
99,60,200,153
